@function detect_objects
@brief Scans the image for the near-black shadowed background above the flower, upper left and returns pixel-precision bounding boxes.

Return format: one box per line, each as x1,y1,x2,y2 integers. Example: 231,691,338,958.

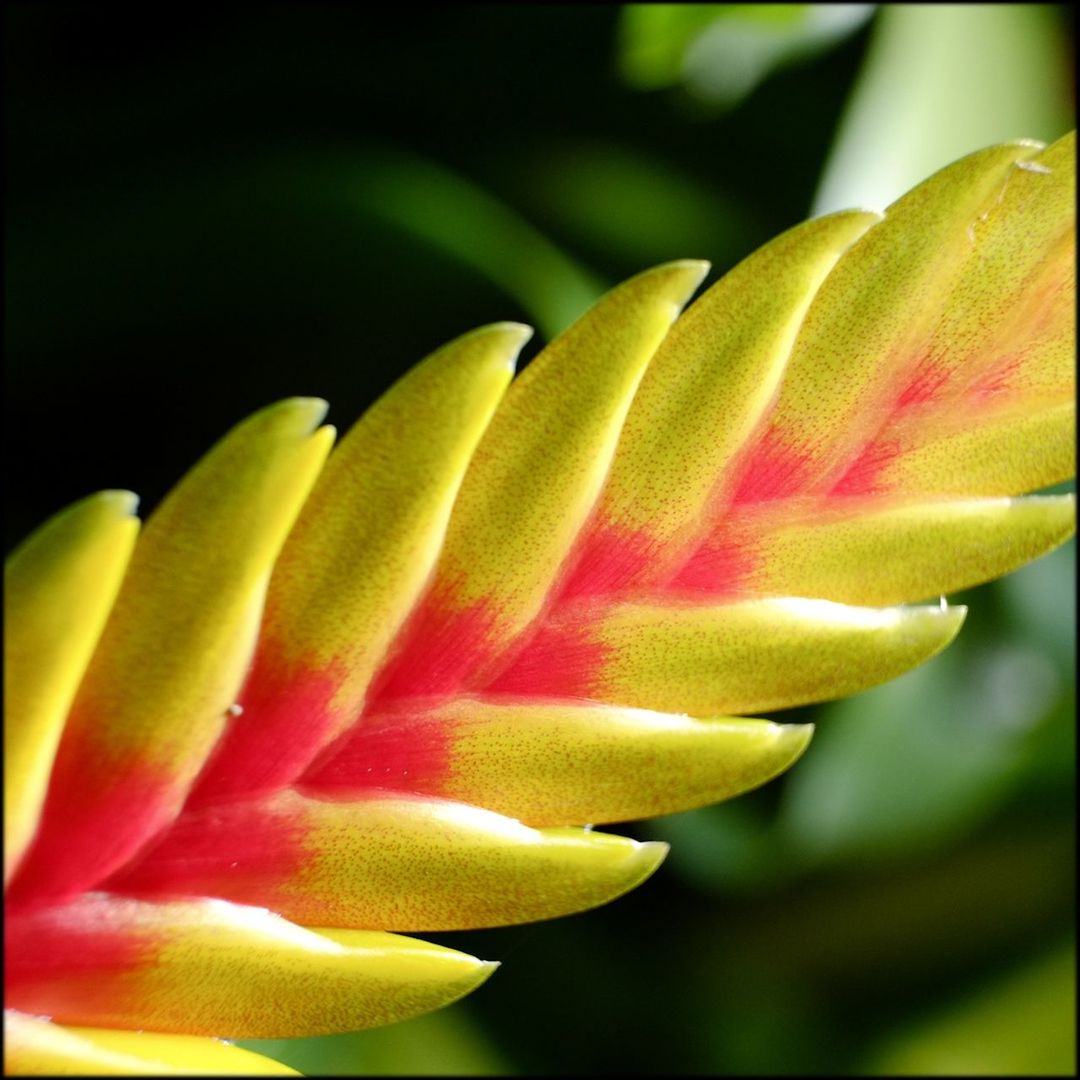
5,4,860,545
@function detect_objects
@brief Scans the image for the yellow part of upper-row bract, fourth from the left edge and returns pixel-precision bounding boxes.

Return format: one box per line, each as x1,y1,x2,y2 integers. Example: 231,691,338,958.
429,260,707,645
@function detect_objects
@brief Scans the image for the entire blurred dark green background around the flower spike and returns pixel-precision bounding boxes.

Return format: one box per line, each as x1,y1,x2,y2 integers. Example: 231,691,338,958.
4,3,1076,1075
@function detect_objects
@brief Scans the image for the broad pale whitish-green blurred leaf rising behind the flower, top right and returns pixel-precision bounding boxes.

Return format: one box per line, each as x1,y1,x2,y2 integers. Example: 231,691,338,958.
813,3,1075,214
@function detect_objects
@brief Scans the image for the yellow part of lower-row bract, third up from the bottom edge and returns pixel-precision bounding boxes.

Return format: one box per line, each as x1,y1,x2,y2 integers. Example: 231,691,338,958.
274,793,667,930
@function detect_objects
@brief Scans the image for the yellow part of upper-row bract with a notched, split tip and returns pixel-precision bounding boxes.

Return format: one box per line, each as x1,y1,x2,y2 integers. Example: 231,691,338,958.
66,397,334,773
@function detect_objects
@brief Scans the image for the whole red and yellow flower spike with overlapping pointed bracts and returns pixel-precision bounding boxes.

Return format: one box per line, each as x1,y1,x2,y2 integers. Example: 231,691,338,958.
4,136,1076,1072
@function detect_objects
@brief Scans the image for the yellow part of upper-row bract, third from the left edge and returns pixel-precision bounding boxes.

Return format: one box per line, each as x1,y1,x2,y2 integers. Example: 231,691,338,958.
264,323,532,721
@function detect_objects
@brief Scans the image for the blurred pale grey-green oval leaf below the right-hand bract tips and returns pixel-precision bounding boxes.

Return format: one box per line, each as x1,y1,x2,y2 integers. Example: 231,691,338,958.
779,637,1067,860
